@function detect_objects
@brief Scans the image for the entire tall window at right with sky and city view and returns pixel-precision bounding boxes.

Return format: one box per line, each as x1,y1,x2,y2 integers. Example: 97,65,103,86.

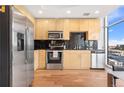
108,6,124,67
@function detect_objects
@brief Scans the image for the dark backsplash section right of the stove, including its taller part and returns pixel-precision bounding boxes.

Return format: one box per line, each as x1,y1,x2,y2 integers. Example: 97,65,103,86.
66,32,98,50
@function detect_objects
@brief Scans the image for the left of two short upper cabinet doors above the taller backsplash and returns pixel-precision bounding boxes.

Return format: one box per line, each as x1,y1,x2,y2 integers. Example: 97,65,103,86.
70,19,80,32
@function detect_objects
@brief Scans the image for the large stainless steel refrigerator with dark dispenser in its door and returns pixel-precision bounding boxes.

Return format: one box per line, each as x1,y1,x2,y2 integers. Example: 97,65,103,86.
10,8,34,87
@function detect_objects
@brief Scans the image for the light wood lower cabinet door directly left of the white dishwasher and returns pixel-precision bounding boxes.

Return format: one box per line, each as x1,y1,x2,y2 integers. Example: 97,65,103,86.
81,51,91,69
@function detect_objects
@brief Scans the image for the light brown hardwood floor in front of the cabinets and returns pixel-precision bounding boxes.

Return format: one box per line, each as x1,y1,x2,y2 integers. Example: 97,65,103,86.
32,70,107,87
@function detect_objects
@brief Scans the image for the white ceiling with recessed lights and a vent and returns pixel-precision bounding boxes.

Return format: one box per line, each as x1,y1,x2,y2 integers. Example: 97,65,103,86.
24,5,119,18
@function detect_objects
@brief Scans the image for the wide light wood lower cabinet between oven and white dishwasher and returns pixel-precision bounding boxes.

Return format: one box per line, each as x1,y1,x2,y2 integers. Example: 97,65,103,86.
63,50,91,69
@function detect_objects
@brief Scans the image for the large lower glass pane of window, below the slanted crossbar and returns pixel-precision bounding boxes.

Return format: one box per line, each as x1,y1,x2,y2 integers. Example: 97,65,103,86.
108,22,124,67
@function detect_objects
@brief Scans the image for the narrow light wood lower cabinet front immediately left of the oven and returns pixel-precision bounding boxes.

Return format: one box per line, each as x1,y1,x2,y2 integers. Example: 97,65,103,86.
38,50,46,69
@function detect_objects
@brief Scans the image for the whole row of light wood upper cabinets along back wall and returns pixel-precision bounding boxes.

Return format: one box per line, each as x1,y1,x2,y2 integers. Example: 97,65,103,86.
35,19,100,40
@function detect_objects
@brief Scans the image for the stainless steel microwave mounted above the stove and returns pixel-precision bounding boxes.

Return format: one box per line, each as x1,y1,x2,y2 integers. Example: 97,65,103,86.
48,31,63,40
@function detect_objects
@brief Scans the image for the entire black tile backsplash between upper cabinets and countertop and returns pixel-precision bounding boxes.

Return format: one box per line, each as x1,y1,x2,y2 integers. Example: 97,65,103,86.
34,32,98,50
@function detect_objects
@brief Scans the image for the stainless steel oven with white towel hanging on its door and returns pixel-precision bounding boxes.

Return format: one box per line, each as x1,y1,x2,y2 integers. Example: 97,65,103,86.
46,50,63,69
